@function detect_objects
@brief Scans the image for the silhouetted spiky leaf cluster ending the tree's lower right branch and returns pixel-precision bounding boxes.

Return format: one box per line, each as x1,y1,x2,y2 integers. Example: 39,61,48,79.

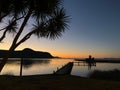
34,8,69,39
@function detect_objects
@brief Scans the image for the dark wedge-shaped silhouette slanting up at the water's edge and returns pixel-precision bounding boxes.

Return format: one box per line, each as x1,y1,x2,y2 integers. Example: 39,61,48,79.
54,62,73,75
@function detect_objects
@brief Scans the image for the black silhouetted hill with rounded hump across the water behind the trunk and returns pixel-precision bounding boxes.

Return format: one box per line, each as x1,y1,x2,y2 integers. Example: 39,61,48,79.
0,48,53,58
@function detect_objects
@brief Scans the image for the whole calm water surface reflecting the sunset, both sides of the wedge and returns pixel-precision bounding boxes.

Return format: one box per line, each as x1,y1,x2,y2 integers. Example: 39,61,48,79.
1,59,120,77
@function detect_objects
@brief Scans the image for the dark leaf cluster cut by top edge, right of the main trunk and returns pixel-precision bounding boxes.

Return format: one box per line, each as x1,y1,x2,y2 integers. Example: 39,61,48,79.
32,0,61,21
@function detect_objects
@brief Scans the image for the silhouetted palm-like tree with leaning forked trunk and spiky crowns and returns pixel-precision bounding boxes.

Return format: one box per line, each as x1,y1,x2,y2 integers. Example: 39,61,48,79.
0,0,69,71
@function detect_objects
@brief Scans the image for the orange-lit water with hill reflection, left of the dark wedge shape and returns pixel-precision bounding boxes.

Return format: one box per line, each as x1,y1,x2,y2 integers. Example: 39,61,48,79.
1,59,73,76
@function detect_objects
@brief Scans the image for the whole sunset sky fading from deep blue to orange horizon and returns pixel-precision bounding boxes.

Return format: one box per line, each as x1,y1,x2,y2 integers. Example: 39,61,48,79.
0,0,120,58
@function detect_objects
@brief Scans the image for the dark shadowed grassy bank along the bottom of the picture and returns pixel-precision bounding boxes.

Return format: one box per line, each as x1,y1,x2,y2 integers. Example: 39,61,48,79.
0,75,120,90
